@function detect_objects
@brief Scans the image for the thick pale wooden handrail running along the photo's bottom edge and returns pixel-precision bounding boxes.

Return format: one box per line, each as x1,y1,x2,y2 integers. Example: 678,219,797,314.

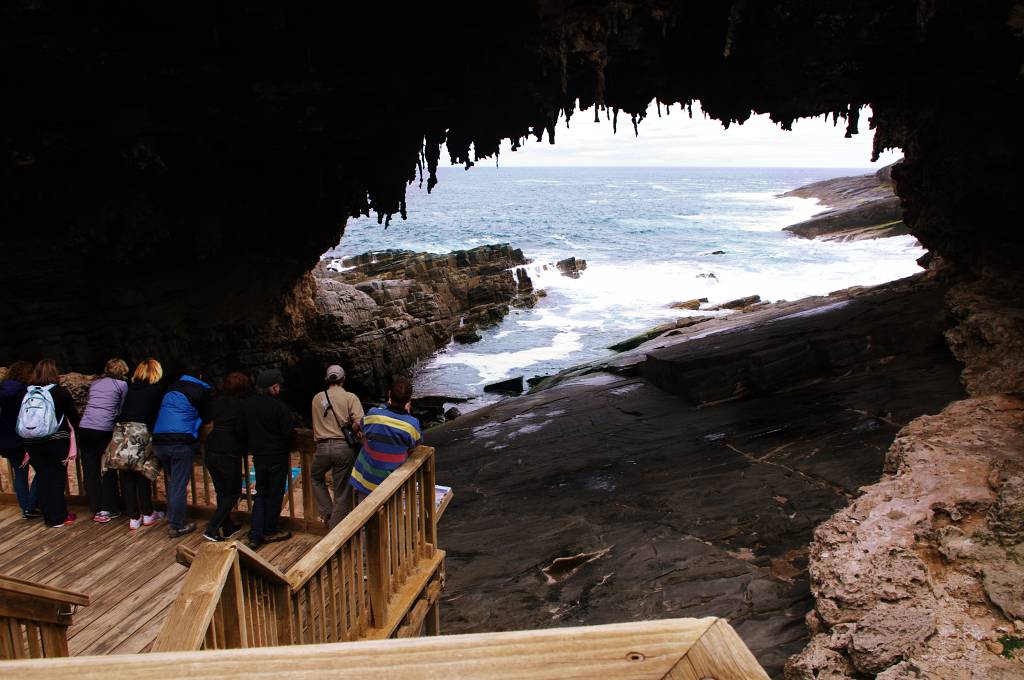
0,618,768,680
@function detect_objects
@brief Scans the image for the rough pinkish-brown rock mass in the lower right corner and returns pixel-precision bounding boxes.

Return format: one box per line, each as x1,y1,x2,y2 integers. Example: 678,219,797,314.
786,395,1024,680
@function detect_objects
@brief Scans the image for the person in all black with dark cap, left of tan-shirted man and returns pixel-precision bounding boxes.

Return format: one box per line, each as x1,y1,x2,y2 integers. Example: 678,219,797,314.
245,369,295,550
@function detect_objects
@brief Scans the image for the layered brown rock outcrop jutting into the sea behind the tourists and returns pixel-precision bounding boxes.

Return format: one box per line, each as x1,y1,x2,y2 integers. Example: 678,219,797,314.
252,244,538,398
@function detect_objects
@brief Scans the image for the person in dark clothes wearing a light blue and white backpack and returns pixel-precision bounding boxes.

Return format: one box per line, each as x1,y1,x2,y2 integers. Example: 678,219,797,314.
15,358,78,528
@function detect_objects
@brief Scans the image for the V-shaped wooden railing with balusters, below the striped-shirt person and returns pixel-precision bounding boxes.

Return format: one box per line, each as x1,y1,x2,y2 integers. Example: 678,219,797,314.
153,447,444,651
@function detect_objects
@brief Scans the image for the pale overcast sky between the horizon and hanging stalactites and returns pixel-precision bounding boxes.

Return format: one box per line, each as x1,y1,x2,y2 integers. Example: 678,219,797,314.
484,105,902,168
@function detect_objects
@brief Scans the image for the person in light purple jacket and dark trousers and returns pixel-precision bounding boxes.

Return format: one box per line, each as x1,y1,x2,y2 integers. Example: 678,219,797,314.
78,358,128,522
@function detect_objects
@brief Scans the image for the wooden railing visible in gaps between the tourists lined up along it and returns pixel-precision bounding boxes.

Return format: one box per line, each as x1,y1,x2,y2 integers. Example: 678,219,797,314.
0,430,327,534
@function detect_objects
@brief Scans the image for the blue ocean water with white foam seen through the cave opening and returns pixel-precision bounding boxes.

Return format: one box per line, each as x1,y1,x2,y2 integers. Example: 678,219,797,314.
326,166,925,411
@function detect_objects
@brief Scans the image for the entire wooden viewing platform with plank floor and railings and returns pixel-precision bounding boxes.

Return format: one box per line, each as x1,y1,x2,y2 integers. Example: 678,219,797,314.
0,438,768,680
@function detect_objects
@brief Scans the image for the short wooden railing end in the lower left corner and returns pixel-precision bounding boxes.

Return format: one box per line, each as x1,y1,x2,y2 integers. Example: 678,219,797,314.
0,577,89,659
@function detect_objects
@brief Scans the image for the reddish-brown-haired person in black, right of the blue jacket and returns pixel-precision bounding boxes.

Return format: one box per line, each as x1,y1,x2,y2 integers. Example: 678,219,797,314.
203,371,253,541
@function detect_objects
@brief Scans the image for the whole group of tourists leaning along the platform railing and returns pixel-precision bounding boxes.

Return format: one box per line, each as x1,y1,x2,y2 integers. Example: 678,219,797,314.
0,358,421,549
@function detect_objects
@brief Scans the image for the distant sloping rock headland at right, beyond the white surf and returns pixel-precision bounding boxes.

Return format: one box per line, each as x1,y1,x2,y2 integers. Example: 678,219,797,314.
779,165,909,241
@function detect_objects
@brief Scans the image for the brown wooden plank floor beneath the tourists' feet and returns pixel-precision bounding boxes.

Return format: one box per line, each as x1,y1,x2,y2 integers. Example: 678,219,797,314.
0,505,321,655
